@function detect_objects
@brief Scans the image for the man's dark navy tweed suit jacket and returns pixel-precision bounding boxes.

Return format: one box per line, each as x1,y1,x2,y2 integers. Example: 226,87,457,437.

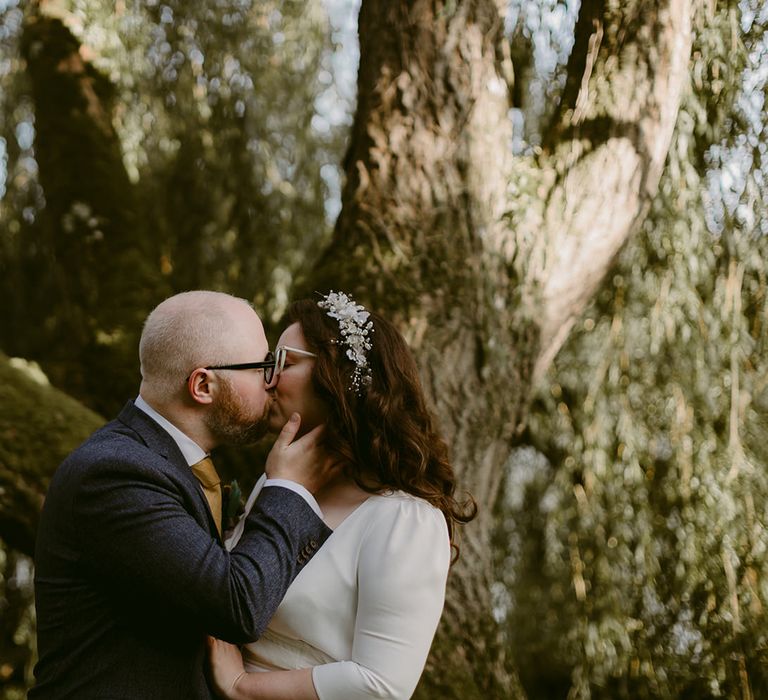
28,401,331,700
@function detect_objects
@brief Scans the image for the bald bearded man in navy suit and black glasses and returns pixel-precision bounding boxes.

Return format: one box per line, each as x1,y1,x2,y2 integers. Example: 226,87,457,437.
28,292,330,700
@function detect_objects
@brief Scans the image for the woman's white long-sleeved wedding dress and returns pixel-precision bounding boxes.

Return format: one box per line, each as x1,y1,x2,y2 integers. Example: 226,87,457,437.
227,477,450,700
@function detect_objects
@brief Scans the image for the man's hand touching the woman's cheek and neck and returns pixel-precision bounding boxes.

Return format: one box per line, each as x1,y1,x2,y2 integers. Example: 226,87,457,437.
265,413,340,494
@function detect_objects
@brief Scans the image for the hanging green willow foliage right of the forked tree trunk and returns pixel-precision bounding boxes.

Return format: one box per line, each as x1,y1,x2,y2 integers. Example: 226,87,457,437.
495,3,768,698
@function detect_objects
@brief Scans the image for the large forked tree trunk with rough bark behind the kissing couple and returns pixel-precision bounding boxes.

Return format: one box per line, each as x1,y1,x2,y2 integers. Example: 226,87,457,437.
306,0,692,700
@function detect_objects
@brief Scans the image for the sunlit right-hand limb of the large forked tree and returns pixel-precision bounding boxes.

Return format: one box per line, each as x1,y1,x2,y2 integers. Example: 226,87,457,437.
529,0,693,377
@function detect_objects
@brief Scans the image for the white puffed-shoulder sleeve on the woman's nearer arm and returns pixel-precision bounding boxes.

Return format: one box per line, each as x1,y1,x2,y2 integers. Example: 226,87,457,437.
312,499,450,700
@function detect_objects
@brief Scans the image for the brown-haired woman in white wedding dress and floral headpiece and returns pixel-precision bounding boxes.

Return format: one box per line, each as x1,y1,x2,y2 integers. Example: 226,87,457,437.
209,292,477,700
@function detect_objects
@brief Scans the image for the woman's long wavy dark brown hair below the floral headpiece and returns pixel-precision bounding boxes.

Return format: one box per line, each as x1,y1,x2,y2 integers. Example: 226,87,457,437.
284,299,477,561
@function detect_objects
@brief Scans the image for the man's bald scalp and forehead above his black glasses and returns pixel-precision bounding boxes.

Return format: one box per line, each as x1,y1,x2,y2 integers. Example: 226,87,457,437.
139,291,267,399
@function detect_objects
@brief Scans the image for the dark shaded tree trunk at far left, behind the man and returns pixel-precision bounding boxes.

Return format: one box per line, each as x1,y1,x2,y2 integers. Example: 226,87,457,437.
13,6,163,414
